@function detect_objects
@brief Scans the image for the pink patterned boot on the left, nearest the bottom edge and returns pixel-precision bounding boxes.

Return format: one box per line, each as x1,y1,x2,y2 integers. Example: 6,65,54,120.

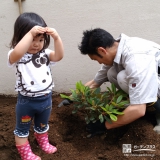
16,141,41,160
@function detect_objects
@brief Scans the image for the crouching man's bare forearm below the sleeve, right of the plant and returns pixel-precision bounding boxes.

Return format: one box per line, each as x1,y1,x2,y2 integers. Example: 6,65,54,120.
105,104,146,129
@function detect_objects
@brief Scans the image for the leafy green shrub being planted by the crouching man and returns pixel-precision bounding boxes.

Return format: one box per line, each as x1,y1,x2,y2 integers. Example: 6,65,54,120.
60,81,129,124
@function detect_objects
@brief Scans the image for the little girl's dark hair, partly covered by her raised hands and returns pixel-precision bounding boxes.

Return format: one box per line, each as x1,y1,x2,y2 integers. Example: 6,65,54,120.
10,12,50,49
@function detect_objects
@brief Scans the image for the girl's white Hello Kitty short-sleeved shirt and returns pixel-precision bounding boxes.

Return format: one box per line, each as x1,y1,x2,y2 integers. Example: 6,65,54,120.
8,49,55,97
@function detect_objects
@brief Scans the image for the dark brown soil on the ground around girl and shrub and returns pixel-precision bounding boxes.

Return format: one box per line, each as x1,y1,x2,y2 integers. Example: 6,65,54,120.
0,94,160,160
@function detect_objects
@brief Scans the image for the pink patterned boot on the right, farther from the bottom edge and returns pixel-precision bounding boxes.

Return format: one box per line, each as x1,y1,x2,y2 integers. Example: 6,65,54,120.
34,132,57,154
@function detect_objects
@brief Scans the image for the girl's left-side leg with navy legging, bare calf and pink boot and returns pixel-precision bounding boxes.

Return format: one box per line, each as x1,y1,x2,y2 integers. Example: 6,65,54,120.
14,95,41,160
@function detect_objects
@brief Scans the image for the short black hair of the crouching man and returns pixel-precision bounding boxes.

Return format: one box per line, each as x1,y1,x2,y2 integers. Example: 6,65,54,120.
78,28,115,57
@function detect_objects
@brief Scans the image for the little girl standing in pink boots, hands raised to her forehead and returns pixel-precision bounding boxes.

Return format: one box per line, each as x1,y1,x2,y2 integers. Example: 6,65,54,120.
8,13,63,160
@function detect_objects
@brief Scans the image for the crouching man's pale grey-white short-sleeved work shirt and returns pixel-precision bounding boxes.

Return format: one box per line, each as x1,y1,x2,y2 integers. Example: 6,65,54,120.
94,34,160,104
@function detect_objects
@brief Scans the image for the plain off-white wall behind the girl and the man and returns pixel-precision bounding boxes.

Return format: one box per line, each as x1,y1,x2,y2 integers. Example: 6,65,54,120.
0,0,160,95
